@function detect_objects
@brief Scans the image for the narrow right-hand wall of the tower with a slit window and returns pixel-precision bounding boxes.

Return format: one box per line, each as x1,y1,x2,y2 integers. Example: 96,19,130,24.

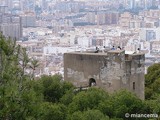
126,54,145,99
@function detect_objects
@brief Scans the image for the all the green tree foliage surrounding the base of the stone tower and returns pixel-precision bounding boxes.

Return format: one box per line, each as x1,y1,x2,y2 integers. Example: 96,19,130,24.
0,35,160,120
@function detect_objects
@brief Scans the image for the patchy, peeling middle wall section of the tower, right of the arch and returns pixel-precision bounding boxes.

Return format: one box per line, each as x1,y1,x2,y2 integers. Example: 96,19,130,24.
100,51,127,92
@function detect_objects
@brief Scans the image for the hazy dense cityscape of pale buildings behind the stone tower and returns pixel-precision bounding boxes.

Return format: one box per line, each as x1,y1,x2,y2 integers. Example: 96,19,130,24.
0,0,160,76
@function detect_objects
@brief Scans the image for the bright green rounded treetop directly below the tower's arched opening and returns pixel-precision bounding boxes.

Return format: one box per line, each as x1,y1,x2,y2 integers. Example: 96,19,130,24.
69,88,109,113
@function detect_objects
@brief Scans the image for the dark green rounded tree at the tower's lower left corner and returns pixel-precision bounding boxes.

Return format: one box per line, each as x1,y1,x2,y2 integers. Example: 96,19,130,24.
40,75,73,103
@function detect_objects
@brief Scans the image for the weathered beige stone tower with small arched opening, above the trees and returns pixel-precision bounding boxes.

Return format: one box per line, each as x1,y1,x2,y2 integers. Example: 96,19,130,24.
64,50,145,99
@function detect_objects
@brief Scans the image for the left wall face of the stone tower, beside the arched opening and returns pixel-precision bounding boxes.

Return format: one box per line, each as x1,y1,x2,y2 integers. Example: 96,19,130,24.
64,53,105,87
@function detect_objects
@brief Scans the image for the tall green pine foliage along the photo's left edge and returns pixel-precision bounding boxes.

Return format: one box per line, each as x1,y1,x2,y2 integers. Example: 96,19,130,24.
0,35,40,120
